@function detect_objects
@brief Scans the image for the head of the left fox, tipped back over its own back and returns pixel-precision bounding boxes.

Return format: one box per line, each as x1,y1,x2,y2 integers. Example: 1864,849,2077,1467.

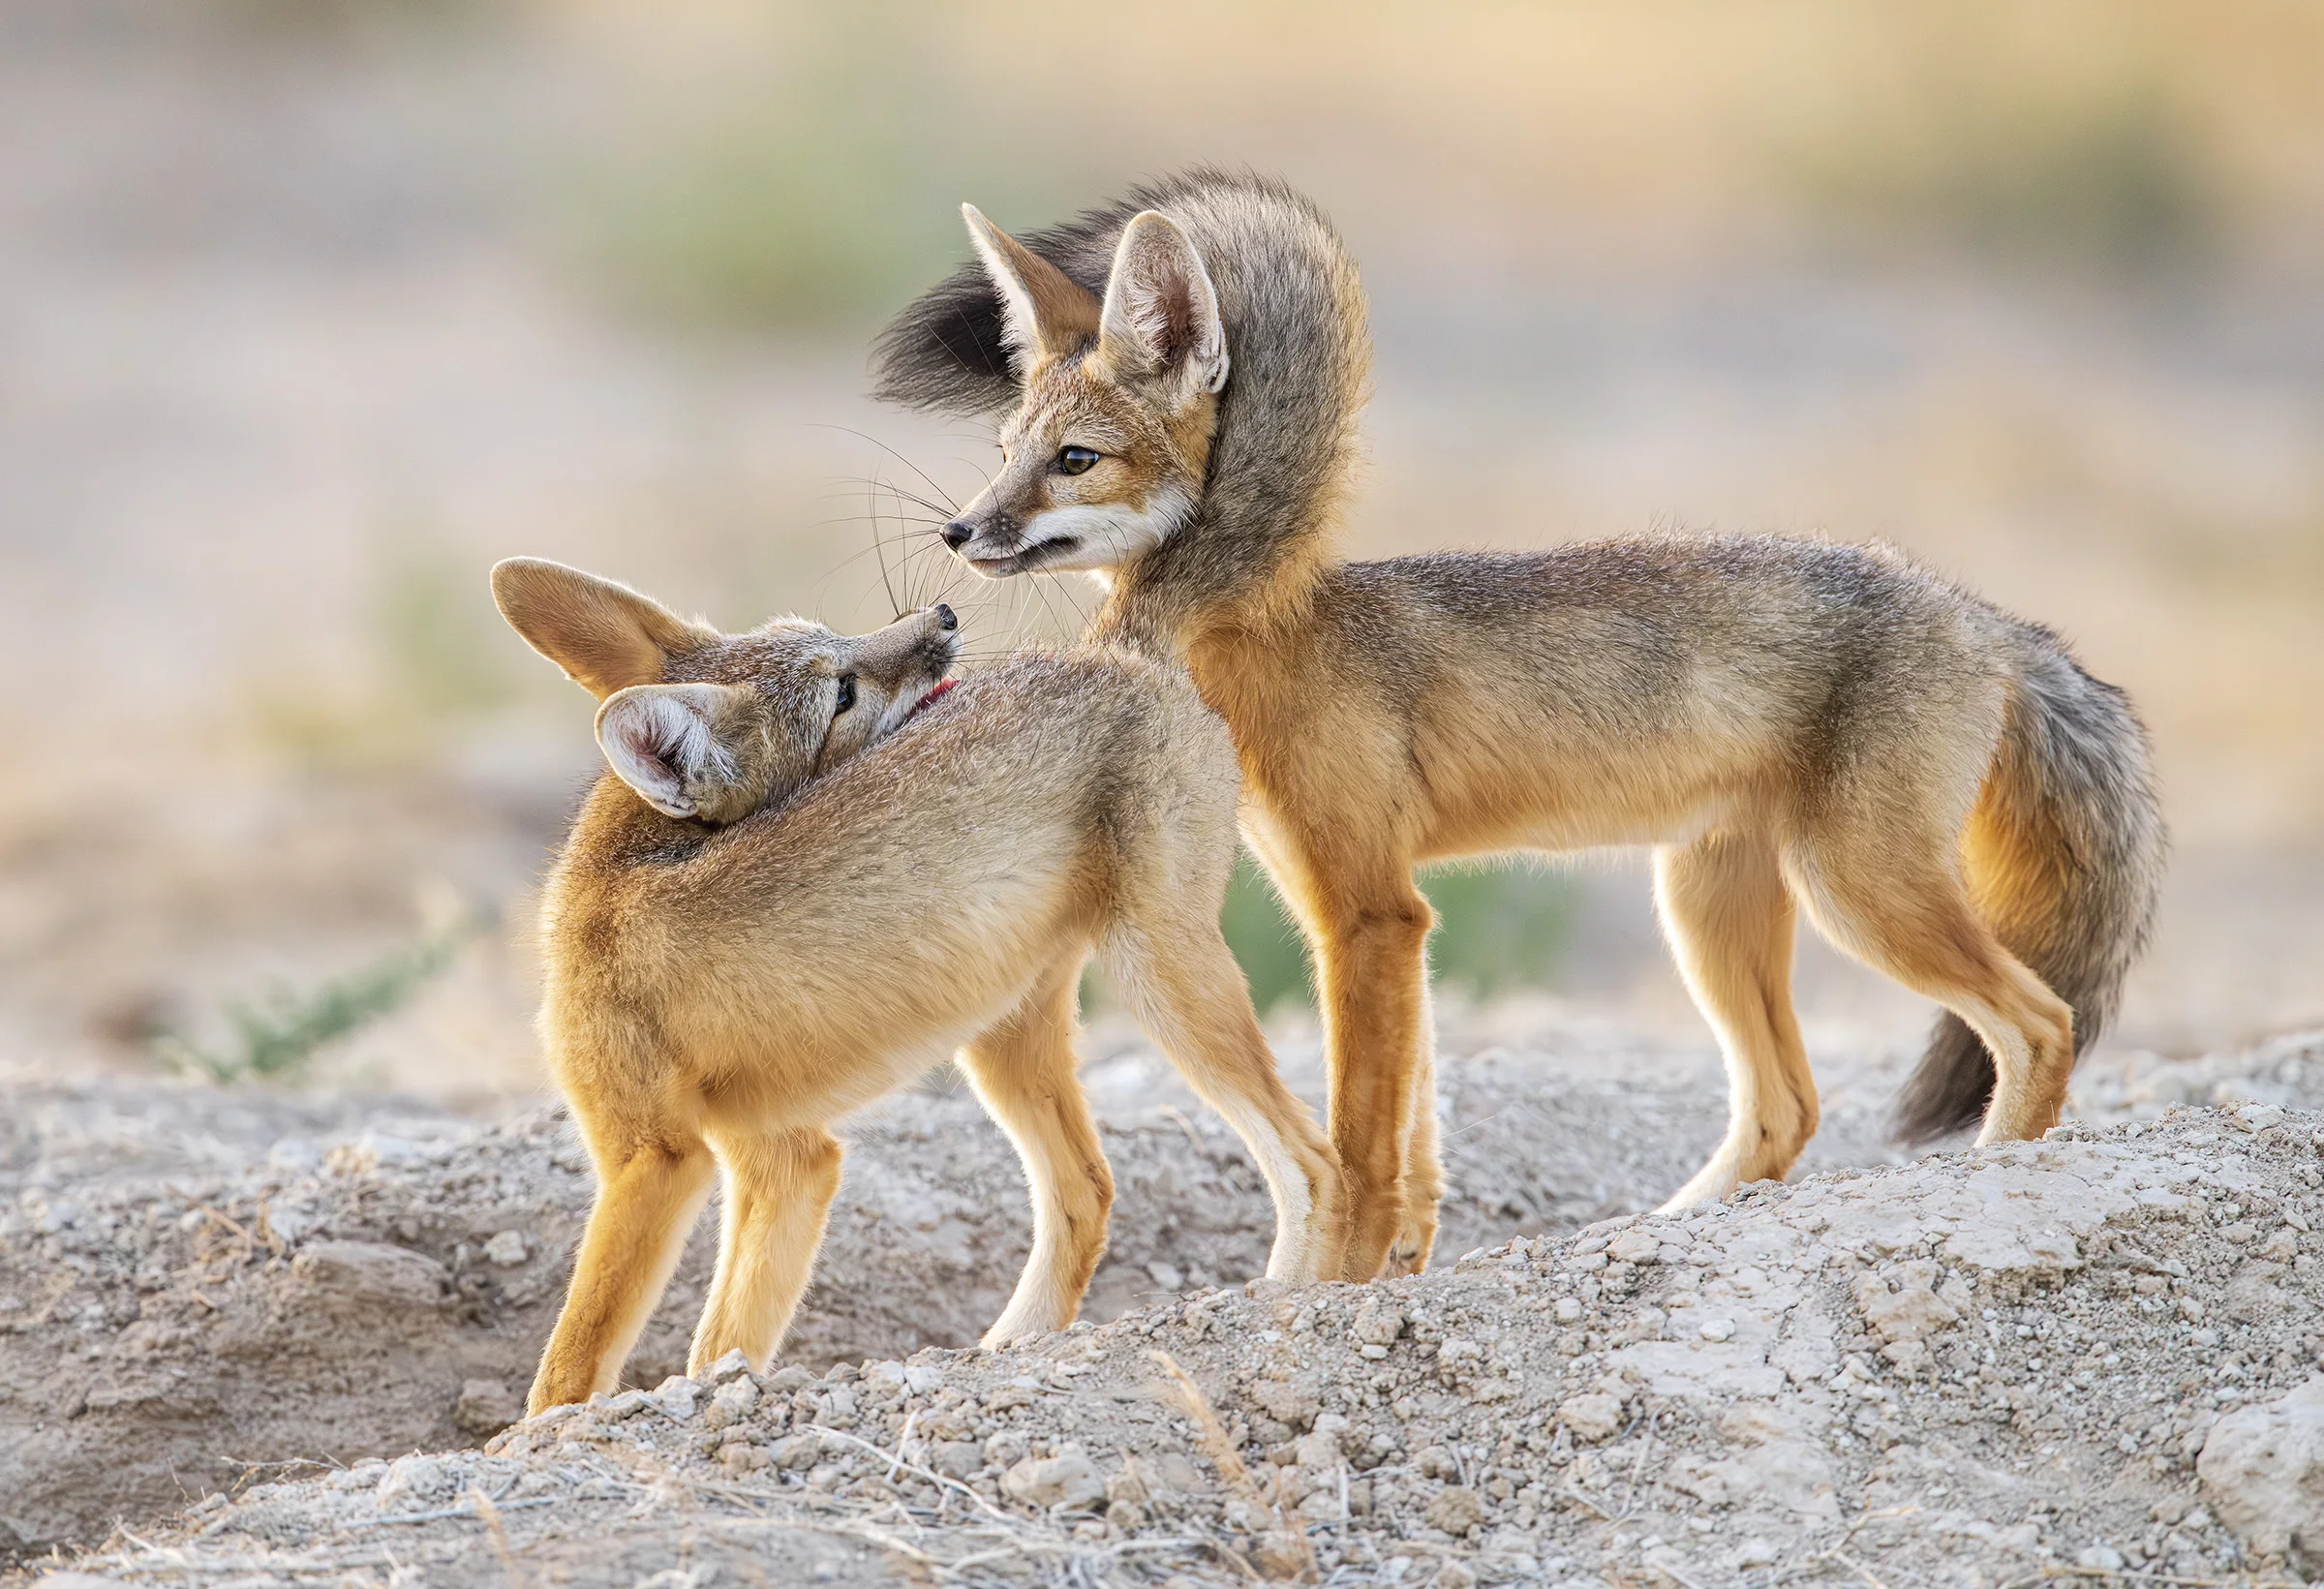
493,558,958,825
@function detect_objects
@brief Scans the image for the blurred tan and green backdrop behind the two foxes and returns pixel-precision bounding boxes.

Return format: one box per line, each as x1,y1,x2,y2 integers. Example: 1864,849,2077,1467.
0,0,2324,1104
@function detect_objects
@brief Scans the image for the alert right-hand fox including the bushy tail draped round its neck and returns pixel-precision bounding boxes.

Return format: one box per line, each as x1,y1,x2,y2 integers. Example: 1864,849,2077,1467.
873,169,2166,1280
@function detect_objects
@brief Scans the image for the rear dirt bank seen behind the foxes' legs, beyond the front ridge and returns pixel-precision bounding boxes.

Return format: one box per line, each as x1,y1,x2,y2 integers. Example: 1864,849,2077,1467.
0,1017,1821,1549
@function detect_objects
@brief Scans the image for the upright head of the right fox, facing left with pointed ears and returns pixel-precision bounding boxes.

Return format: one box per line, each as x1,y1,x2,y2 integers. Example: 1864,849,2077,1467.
943,204,1227,578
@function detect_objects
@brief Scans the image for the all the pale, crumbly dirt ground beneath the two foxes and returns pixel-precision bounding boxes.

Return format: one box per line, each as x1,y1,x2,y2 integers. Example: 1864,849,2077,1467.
0,1031,2324,1582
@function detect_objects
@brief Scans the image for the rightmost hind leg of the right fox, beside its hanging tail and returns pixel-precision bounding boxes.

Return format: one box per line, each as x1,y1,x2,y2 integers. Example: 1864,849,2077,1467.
1785,829,2073,1146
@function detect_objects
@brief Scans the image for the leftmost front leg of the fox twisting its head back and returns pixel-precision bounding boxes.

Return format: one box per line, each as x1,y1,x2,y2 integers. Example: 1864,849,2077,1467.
525,1108,716,1413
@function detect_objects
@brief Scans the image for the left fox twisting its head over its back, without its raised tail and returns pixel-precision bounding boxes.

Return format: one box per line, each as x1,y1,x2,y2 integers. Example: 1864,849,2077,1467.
493,558,1343,1413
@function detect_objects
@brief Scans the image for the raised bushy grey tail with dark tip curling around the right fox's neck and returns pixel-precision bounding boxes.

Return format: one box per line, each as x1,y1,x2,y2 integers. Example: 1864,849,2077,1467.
872,168,1371,648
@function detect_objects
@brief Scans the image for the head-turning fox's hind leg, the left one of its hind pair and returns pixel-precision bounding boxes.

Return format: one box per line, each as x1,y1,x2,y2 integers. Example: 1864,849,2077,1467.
960,953,1114,1347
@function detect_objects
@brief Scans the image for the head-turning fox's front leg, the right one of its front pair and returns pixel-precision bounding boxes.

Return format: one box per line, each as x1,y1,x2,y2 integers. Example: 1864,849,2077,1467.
686,1127,839,1375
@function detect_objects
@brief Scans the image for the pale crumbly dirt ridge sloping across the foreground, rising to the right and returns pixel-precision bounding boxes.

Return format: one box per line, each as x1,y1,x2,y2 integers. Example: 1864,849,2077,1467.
22,1104,2324,1589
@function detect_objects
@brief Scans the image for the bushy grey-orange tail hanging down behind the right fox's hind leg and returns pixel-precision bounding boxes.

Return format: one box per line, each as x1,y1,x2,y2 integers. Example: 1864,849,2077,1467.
1896,625,2168,1143
